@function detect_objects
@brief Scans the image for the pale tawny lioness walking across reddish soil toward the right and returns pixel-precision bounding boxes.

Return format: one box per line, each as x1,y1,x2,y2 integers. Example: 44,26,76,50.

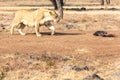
10,9,60,36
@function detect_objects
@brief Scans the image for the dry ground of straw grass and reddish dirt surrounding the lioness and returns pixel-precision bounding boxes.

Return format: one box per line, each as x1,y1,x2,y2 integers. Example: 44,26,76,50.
0,6,120,80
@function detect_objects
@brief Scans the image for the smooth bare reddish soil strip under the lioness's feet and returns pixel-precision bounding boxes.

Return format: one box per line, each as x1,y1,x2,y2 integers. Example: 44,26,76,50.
0,30,120,55
